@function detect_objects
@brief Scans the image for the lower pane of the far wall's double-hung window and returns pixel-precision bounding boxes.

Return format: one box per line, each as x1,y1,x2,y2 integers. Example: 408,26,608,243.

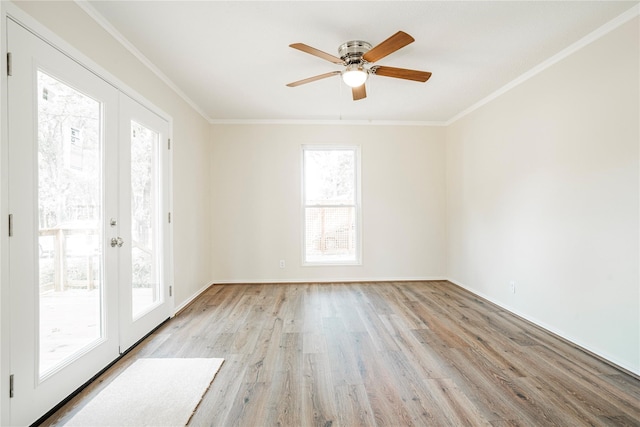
305,206,356,262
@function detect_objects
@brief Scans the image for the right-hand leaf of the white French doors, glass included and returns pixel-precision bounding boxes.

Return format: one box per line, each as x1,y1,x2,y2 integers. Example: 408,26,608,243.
118,94,172,351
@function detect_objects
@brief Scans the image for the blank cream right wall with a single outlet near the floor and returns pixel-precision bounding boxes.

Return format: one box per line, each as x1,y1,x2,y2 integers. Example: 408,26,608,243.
446,18,640,373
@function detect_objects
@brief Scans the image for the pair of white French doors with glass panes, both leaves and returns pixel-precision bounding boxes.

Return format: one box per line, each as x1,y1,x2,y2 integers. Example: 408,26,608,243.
6,19,170,425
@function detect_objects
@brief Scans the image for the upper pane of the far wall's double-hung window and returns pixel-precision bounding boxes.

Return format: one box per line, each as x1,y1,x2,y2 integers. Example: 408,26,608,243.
304,150,356,205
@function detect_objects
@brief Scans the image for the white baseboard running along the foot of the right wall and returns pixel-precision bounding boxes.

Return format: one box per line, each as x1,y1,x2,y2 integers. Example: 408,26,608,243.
444,278,640,379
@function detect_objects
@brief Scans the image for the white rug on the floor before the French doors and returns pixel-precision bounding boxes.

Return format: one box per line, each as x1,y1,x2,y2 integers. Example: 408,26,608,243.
65,359,224,427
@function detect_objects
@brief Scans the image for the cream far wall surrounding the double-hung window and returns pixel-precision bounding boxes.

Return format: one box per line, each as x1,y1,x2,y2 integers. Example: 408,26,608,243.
211,125,445,283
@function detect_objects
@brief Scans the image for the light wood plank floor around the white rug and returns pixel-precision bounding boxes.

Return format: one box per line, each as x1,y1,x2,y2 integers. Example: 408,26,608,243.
44,282,640,427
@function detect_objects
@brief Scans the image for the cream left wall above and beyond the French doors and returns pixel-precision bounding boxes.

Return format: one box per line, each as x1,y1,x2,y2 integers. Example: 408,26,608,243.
10,1,211,306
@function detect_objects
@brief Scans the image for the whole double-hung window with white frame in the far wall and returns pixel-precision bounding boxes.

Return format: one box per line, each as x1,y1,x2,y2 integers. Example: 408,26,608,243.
302,146,361,265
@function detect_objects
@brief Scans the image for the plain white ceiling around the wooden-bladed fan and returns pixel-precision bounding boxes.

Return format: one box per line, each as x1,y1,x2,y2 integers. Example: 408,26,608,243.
79,1,638,123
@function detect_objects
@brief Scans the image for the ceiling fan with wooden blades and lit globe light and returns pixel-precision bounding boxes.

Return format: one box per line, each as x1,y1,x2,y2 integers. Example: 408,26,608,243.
287,31,431,101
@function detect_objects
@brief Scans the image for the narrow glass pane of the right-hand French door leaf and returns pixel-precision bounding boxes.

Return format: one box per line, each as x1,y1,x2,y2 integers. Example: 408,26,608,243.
131,121,161,319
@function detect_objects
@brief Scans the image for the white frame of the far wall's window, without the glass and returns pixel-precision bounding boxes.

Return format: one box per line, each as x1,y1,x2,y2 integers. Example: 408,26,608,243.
300,143,362,267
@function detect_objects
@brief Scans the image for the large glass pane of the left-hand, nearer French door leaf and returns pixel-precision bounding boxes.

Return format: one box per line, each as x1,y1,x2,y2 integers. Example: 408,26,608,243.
37,71,103,378
